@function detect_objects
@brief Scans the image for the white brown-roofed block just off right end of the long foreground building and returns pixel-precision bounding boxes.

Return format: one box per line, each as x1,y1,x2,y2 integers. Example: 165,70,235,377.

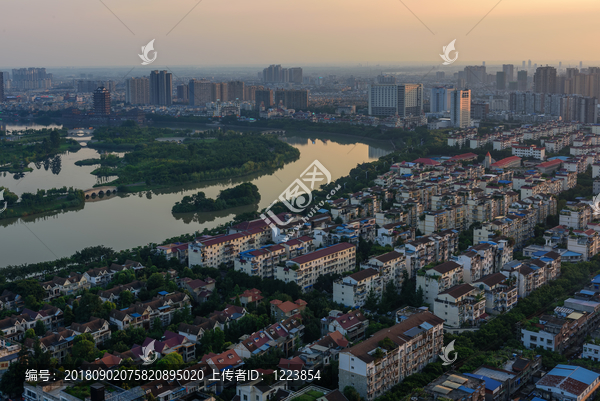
433,283,486,328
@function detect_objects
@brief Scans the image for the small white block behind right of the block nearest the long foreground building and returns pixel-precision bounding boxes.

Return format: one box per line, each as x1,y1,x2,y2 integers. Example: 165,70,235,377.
473,273,518,315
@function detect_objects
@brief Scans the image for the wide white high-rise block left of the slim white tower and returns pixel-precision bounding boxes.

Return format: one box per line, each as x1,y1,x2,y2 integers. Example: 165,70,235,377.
368,84,423,117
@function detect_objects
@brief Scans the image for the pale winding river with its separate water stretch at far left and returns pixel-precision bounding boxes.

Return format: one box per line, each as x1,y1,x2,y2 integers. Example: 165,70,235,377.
0,125,392,267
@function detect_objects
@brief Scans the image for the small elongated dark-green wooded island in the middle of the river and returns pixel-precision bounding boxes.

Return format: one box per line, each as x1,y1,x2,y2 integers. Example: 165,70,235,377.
172,182,260,213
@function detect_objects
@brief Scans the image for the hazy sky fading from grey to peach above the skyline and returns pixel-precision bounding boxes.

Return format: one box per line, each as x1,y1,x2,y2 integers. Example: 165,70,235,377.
0,0,600,68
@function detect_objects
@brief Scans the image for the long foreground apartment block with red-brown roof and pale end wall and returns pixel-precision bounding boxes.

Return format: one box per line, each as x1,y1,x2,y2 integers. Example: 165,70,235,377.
338,311,444,401
